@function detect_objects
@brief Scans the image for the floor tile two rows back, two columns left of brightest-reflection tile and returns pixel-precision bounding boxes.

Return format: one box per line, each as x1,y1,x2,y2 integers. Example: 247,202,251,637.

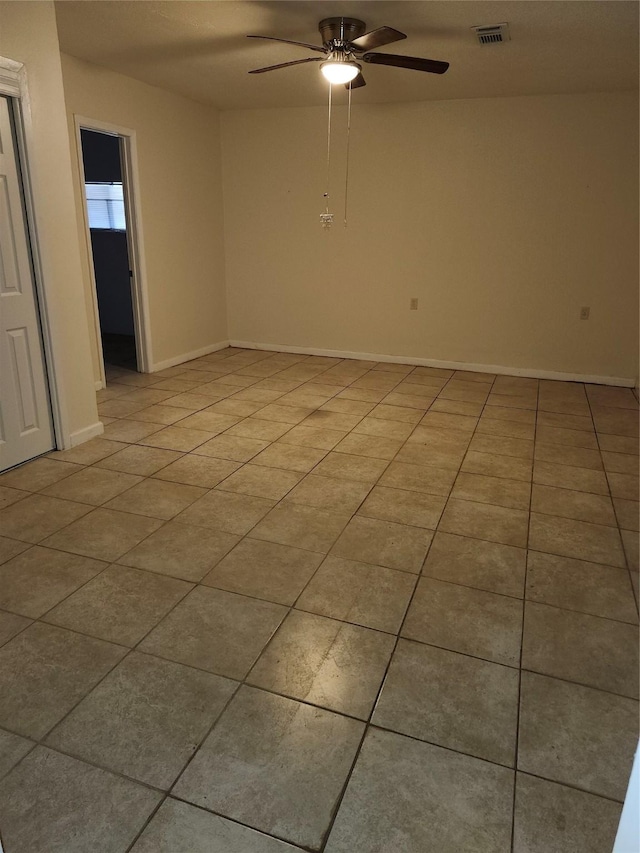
177,489,275,536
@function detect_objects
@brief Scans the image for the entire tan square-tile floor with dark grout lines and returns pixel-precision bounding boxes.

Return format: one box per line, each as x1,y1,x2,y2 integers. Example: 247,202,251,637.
0,349,638,853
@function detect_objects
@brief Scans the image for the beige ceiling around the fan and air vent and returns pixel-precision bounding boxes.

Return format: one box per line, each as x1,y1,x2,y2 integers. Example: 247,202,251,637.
56,0,638,109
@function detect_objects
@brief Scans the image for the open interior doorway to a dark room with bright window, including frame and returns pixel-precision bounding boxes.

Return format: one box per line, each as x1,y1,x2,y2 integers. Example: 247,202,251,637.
76,117,152,387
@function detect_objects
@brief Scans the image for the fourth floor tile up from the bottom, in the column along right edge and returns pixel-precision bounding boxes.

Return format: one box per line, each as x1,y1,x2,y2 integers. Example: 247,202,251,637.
527,551,638,623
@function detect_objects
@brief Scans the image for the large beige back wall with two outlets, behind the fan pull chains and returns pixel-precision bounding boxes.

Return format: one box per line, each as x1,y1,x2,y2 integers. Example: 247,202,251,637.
222,93,638,378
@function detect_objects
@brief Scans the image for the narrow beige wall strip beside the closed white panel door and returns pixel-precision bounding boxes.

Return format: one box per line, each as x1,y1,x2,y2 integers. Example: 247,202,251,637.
0,2,99,445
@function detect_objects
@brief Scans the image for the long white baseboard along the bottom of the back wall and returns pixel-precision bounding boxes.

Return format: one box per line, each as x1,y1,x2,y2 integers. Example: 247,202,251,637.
228,341,635,388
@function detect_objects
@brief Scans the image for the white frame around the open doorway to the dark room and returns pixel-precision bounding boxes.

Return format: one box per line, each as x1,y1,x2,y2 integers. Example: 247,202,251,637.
73,114,153,388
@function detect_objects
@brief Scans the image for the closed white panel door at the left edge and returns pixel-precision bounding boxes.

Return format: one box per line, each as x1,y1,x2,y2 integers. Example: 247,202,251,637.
0,97,54,471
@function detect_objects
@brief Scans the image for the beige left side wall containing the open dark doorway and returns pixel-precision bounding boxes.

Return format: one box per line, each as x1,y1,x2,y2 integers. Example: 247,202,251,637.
62,54,227,378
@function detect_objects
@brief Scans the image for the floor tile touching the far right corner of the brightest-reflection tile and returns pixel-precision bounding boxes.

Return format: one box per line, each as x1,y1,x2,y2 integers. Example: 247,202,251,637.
402,577,522,667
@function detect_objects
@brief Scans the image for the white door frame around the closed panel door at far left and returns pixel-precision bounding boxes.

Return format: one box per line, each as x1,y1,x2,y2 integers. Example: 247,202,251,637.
0,56,71,448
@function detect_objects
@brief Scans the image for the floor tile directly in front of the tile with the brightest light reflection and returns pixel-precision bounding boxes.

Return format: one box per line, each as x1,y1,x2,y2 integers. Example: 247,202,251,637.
176,687,364,849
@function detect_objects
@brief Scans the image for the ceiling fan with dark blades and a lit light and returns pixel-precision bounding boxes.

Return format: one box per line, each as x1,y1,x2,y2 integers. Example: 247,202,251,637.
247,18,449,89
